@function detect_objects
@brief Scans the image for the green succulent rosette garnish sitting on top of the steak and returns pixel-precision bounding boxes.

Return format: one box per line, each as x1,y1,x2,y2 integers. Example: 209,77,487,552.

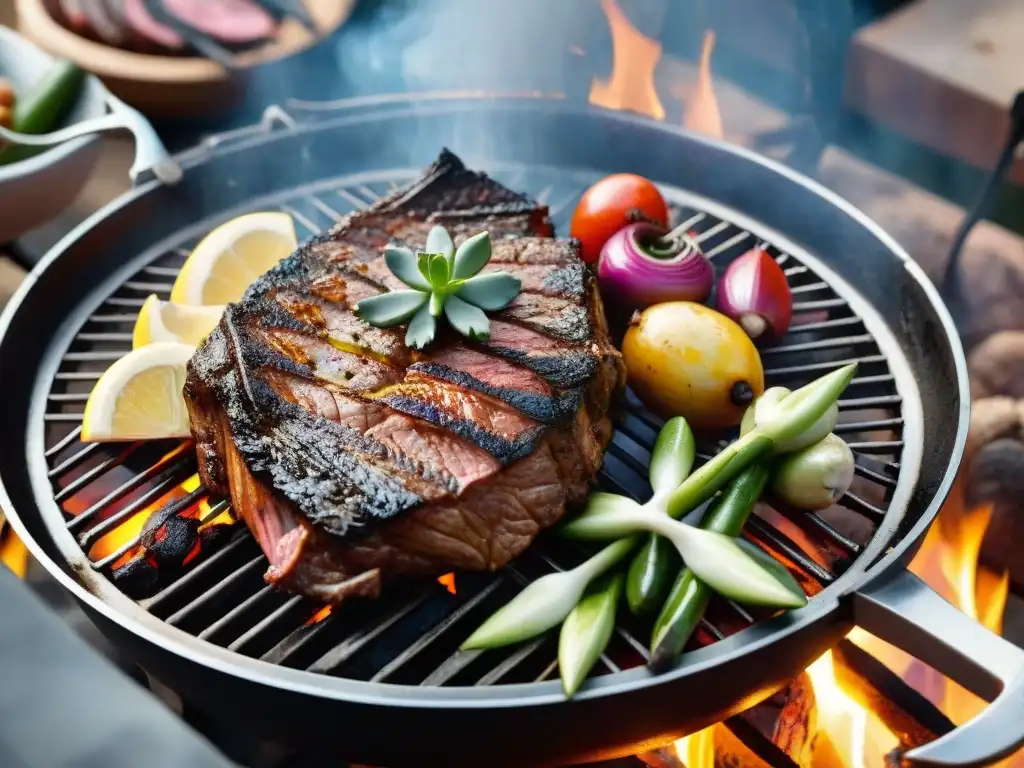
353,225,522,349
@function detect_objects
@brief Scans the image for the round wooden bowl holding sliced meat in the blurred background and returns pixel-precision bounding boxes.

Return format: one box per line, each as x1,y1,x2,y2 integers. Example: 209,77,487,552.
16,0,355,117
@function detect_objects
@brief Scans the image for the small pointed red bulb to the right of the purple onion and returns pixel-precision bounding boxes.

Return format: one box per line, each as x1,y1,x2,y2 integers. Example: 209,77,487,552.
717,247,793,340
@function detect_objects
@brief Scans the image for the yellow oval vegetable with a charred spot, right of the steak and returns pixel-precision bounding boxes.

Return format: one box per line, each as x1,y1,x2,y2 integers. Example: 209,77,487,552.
623,301,765,430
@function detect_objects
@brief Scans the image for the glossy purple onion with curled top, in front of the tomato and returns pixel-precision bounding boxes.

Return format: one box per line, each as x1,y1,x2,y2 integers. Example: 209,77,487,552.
597,222,715,309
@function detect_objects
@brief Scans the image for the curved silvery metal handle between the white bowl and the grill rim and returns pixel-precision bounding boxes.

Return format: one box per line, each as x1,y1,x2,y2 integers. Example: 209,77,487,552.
0,95,181,184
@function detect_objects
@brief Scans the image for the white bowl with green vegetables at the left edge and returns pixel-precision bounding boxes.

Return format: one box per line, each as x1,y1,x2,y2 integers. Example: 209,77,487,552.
0,27,108,243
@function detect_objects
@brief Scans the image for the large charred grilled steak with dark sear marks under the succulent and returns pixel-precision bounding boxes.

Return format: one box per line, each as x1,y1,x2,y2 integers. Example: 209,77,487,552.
185,151,624,603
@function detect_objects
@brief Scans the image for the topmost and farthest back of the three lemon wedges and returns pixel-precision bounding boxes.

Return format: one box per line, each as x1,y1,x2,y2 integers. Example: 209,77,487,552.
171,212,298,306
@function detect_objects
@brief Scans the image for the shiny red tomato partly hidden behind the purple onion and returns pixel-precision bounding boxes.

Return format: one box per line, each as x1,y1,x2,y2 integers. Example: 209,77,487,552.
569,173,669,264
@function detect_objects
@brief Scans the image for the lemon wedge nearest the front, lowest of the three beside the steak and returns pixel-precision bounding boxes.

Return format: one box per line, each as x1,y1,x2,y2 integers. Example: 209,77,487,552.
82,341,196,441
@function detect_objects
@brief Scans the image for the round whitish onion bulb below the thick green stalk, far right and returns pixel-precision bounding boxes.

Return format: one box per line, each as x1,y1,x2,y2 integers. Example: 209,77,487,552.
772,433,854,510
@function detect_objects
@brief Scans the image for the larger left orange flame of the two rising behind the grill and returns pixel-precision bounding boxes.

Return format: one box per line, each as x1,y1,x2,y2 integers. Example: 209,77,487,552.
588,0,665,120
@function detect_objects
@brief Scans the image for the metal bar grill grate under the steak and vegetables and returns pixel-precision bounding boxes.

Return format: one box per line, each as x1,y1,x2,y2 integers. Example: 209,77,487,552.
44,167,903,686
